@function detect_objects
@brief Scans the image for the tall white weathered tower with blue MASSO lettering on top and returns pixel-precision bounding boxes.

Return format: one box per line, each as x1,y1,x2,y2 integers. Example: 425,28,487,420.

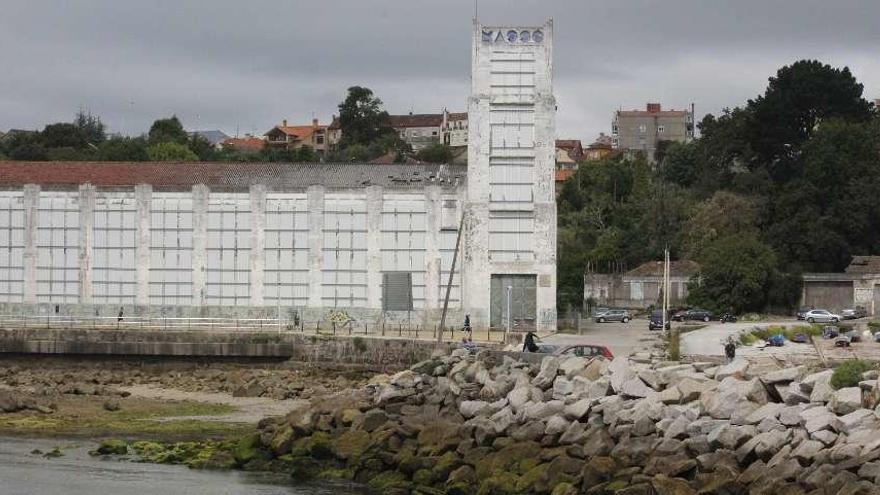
462,19,556,331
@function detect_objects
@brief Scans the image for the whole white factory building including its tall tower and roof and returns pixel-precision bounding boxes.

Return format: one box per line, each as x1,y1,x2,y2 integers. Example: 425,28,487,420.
0,17,556,330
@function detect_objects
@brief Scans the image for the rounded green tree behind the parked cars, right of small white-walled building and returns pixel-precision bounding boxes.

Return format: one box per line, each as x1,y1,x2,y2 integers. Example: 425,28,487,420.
688,234,777,312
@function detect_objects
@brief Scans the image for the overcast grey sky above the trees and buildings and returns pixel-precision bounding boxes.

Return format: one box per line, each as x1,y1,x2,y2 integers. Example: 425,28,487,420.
0,0,880,144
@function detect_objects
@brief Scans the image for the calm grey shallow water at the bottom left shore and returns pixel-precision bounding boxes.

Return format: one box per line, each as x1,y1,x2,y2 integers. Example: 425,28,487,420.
0,437,363,495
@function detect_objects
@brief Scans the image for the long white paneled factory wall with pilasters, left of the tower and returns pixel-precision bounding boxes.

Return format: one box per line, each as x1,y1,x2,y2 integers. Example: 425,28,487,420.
0,184,463,328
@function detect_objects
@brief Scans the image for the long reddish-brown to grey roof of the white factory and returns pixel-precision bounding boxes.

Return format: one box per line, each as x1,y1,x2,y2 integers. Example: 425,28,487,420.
0,161,467,190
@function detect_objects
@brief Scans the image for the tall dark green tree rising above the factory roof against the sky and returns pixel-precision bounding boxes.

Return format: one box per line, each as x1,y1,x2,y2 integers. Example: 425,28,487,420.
339,86,394,148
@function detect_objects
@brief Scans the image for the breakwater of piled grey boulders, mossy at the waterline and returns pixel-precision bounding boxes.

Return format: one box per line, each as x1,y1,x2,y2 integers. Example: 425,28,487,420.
260,350,880,495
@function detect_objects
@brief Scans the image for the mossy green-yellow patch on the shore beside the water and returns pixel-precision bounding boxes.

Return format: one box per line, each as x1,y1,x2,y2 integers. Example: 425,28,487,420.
0,396,253,441
